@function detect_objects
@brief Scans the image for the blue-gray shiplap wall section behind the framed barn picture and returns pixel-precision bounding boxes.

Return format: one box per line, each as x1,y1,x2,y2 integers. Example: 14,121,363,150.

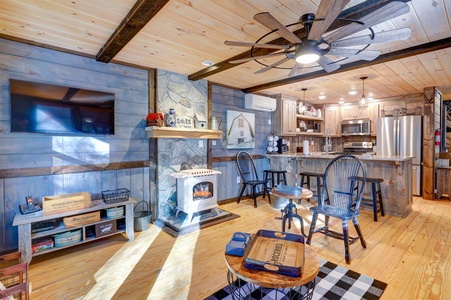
212,85,272,200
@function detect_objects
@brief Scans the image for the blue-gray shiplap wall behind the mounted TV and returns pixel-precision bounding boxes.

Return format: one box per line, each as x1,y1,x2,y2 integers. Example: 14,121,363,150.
0,39,150,252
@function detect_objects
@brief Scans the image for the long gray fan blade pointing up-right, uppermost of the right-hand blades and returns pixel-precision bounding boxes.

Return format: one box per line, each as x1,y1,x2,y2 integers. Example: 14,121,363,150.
324,1,410,43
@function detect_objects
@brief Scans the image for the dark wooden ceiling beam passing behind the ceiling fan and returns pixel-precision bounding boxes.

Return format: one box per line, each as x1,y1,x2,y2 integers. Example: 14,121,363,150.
188,0,411,81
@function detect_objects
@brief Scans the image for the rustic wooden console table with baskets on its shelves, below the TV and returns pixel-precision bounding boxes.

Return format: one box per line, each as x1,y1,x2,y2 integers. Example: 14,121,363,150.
13,198,136,263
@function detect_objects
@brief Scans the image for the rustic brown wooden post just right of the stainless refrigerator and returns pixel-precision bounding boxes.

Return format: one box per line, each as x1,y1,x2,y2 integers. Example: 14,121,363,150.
422,87,435,200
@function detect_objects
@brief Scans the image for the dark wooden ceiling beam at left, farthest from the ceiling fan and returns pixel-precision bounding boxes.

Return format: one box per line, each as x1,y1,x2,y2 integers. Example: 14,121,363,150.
96,0,169,63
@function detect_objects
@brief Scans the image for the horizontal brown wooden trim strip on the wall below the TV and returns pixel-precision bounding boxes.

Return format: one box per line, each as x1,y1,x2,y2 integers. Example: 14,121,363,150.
0,160,150,179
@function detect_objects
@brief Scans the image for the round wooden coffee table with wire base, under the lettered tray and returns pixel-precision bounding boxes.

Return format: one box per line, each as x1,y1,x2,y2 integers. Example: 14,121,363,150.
225,245,320,299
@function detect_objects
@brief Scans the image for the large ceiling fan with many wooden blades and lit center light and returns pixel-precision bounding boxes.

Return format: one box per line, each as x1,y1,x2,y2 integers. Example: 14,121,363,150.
224,0,411,76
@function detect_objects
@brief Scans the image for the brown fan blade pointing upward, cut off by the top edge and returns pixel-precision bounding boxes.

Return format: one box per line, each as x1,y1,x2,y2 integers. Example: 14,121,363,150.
308,0,349,41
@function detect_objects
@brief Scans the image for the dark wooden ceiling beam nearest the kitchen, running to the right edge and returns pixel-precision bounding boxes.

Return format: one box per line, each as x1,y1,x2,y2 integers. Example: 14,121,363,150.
242,37,451,93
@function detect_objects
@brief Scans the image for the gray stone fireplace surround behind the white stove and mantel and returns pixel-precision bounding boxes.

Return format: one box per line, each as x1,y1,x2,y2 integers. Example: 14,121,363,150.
151,70,212,227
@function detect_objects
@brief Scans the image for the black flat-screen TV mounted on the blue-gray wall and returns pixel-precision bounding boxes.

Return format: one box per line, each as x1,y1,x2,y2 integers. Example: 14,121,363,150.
9,79,115,135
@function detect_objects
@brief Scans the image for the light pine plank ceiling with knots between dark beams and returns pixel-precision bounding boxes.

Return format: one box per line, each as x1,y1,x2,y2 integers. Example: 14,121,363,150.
0,0,451,103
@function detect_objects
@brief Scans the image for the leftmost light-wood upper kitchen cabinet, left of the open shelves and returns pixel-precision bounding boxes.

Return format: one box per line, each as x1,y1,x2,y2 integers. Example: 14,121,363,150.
273,95,297,136
